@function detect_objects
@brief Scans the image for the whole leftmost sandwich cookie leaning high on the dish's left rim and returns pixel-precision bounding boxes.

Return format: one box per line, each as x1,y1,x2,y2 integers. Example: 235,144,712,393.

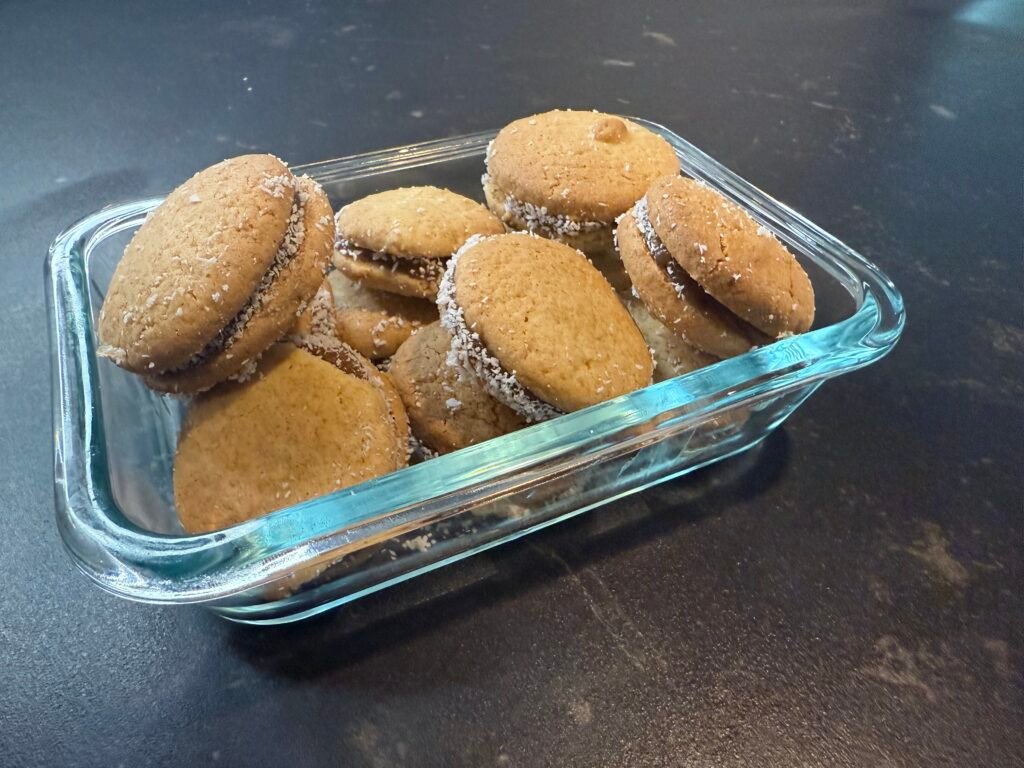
97,155,334,393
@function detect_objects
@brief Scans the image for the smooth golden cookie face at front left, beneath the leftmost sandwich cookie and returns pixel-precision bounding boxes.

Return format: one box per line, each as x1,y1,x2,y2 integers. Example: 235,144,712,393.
174,344,406,532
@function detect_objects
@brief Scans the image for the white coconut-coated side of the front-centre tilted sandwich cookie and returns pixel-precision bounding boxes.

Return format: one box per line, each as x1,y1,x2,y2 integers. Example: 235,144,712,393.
437,234,562,422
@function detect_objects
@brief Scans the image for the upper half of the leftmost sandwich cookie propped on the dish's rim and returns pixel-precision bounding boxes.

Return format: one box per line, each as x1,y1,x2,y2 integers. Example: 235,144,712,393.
98,155,296,373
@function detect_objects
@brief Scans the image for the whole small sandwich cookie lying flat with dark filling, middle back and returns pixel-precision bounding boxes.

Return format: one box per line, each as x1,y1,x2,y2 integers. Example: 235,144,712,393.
334,186,505,300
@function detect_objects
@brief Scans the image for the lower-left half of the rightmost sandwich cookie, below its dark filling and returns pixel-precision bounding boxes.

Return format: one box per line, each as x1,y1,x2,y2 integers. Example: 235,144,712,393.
615,205,767,357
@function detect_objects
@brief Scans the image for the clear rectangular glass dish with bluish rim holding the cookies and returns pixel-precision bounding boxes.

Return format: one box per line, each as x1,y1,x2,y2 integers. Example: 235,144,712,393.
46,120,904,624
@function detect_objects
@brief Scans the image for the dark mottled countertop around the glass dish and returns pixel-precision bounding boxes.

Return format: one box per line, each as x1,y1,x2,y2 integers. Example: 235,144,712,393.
0,0,1024,767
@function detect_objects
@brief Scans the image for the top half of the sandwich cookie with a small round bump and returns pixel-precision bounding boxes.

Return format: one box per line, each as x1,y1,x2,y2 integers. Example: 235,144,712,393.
487,110,679,223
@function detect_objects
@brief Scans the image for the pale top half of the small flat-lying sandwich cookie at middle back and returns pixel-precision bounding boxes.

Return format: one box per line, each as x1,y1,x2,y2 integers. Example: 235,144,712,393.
337,186,505,259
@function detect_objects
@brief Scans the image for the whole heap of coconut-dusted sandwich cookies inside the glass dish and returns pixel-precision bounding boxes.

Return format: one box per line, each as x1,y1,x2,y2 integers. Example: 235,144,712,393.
98,111,814,531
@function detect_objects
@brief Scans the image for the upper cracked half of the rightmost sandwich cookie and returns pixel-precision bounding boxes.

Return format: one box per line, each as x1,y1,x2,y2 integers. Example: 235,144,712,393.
646,176,814,338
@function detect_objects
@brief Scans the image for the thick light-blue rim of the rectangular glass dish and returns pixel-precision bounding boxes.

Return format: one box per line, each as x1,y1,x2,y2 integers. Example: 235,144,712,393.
47,121,905,606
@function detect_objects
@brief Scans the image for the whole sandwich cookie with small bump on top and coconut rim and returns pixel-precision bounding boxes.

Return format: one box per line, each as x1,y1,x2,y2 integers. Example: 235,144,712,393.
482,110,679,256
